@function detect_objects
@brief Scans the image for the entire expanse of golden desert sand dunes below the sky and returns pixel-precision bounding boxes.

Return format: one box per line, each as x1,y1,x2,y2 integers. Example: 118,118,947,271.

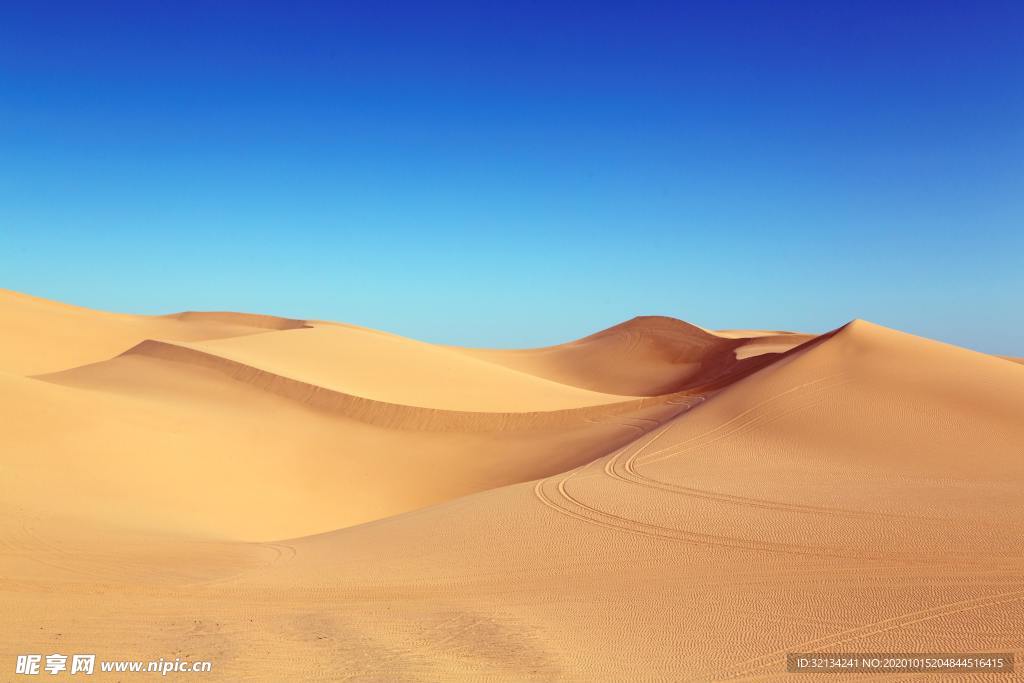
0,292,1024,681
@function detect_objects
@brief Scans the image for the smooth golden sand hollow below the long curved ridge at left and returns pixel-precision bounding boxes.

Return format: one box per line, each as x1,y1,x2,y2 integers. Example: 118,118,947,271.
9,354,687,541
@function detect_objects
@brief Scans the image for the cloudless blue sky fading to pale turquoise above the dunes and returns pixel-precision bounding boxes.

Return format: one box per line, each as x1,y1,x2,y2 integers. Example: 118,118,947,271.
0,0,1024,355
